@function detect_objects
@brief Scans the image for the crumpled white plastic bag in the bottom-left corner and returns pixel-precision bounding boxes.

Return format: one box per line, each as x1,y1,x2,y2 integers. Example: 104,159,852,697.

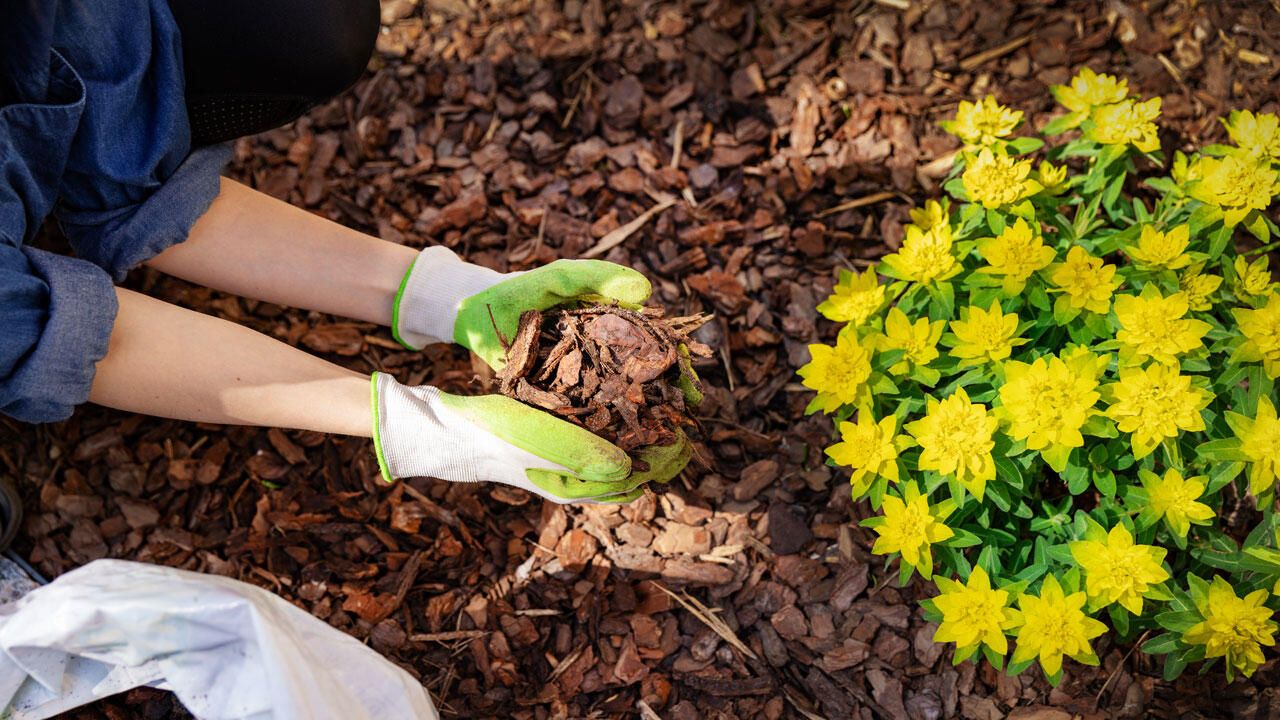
0,560,439,720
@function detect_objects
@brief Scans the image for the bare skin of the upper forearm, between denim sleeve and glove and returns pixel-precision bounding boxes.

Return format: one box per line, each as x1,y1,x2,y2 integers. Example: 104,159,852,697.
147,178,417,325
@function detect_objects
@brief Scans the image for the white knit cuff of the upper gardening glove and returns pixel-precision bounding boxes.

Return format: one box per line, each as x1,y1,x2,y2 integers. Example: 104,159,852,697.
392,245,507,350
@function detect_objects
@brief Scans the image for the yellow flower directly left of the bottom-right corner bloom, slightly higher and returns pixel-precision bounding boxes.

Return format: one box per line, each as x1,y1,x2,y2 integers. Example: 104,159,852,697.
1070,517,1169,615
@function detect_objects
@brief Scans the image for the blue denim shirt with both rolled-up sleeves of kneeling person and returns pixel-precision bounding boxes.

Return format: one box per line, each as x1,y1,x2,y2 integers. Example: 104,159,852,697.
0,0,229,423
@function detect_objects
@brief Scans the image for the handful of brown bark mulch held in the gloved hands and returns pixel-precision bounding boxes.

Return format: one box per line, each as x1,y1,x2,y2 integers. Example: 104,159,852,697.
498,304,712,452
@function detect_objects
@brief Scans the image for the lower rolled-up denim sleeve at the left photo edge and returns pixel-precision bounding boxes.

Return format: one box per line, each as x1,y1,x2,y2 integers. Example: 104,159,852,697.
0,243,116,423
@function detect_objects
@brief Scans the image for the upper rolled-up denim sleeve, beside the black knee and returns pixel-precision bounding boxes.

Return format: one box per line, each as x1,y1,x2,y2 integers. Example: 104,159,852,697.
54,0,230,281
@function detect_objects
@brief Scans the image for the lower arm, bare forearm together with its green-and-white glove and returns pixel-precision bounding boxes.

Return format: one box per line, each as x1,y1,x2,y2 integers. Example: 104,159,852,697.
90,288,646,502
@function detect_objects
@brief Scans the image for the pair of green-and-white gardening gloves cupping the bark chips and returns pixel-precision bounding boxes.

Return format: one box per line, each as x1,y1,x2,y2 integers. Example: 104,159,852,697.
372,247,692,502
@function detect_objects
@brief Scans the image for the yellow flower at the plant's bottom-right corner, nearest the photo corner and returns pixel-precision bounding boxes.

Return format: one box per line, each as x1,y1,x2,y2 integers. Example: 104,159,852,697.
1183,575,1276,680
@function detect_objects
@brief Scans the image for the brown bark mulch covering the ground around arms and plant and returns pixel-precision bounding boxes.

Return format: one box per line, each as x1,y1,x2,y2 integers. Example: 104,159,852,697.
0,0,1280,720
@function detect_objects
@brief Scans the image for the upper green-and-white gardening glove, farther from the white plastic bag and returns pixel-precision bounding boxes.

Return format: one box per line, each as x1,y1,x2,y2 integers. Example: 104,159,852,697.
392,246,652,370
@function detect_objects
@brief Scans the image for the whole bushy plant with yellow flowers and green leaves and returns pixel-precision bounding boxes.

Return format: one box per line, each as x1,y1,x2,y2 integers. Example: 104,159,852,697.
800,69,1280,683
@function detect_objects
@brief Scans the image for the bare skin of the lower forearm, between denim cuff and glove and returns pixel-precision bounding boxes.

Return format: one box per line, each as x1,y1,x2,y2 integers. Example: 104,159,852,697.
90,288,371,437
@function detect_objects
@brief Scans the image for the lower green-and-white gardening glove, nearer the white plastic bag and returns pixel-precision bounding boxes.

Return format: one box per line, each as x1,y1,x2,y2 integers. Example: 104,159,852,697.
371,373,650,503
